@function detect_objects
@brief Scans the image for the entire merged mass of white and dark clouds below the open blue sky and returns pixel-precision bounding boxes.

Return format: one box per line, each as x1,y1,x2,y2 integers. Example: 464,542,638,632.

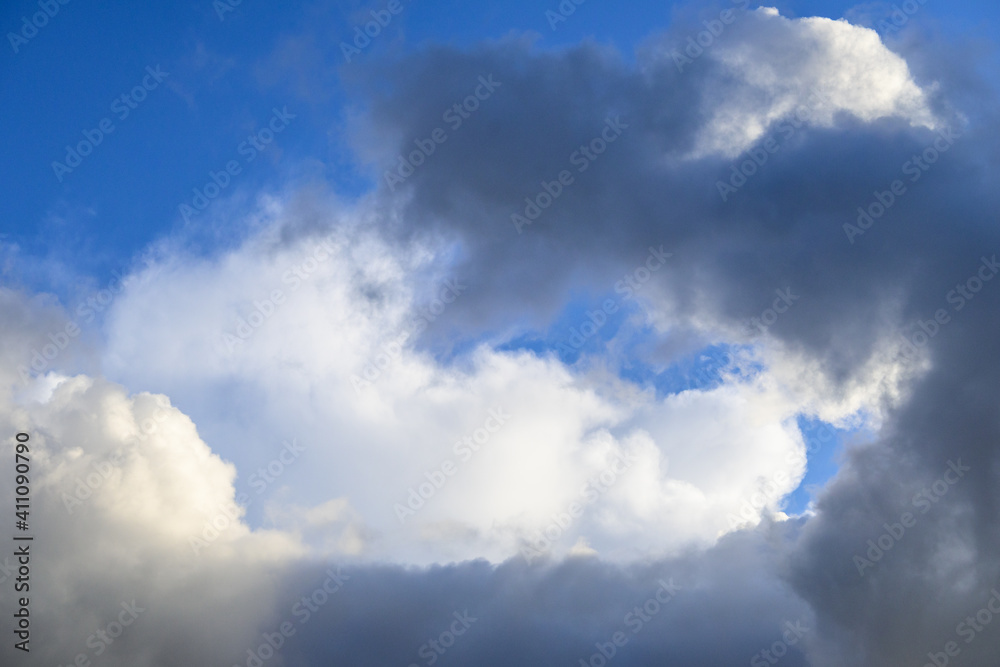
0,2,1000,667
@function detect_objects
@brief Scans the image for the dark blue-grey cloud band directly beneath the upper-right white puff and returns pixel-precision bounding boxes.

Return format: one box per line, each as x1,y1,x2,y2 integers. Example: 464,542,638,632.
344,17,993,372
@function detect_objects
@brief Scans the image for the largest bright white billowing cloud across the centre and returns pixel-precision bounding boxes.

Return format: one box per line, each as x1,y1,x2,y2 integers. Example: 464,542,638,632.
92,197,836,562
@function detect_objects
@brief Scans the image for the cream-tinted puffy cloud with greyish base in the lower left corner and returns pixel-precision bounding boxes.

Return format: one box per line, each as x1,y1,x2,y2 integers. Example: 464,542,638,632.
0,354,304,665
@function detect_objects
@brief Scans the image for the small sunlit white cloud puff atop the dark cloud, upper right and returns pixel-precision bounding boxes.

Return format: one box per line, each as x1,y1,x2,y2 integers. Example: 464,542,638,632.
693,7,940,158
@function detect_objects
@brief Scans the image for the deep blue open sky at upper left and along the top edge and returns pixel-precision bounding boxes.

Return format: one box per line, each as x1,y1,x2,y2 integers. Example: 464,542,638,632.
0,0,998,291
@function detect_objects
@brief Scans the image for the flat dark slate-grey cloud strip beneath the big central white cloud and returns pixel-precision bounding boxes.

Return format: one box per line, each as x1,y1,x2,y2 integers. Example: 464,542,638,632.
232,526,815,667
